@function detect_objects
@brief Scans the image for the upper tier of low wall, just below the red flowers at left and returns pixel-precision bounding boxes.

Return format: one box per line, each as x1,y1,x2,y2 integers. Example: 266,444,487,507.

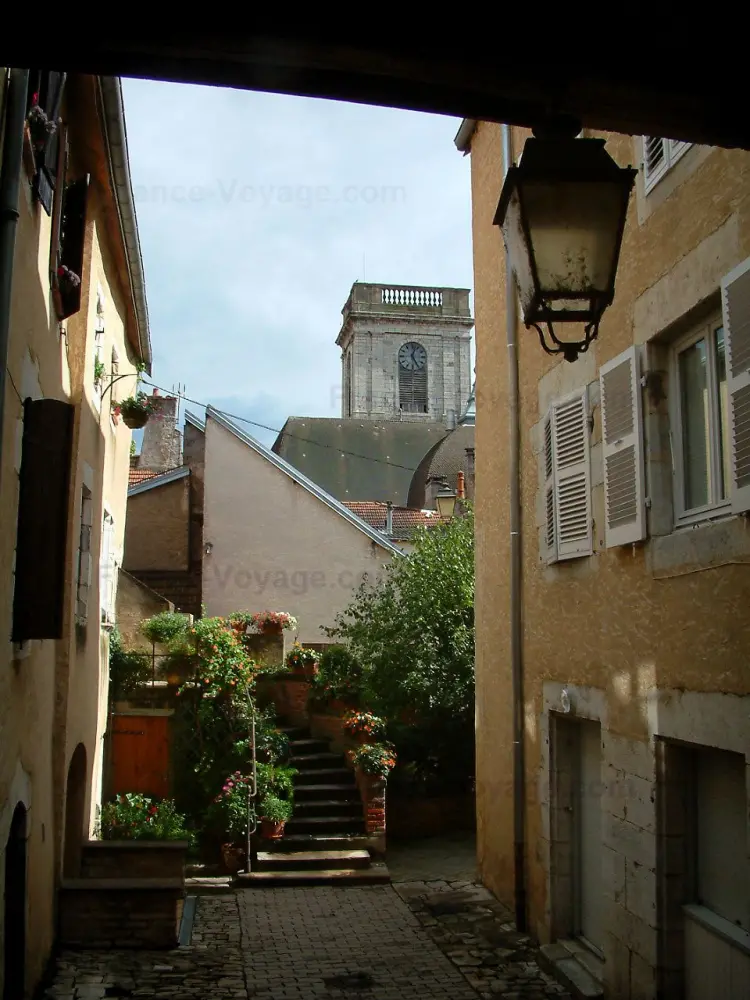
81,840,188,879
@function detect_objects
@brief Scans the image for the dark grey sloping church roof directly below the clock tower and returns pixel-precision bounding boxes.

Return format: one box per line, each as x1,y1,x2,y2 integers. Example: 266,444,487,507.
273,417,446,507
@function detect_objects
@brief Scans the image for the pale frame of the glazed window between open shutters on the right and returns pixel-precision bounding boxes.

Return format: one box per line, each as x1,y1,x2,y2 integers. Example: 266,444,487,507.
669,310,732,528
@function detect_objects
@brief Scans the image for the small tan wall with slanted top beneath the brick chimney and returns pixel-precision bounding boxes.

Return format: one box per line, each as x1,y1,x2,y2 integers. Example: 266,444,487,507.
123,476,190,576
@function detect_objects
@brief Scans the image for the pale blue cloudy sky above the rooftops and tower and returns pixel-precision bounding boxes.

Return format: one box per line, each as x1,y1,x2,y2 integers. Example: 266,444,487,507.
123,80,472,444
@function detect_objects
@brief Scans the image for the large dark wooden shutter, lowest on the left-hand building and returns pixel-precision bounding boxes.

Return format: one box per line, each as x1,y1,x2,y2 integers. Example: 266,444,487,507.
12,399,74,642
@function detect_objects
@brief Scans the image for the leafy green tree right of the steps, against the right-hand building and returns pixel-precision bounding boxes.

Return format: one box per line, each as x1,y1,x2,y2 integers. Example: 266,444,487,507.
326,505,474,778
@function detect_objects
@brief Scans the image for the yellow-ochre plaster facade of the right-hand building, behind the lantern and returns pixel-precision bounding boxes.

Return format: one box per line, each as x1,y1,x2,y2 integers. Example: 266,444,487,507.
470,123,750,998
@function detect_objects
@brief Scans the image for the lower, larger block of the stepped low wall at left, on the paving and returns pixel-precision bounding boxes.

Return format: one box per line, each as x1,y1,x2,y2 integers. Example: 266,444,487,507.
59,878,185,949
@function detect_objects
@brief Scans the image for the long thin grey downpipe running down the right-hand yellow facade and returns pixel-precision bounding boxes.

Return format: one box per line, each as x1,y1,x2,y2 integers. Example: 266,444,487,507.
502,125,526,932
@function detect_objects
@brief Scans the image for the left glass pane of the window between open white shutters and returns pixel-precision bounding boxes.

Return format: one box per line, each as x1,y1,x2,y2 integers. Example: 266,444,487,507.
679,339,711,510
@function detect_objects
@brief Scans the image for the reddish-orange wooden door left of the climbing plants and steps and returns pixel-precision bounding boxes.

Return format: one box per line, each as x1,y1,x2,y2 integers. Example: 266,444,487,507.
112,715,169,798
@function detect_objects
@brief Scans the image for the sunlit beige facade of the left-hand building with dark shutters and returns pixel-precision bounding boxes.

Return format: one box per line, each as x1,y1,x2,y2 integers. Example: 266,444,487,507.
0,74,150,994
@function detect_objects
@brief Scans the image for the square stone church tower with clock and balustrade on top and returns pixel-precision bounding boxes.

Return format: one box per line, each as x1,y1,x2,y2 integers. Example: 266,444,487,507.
336,281,474,427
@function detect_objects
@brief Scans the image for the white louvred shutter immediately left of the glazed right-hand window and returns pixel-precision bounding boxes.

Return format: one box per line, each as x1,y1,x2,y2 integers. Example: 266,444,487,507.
599,347,646,549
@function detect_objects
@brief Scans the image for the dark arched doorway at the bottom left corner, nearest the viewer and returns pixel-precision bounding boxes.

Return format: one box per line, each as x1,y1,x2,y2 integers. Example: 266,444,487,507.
3,803,27,1000
